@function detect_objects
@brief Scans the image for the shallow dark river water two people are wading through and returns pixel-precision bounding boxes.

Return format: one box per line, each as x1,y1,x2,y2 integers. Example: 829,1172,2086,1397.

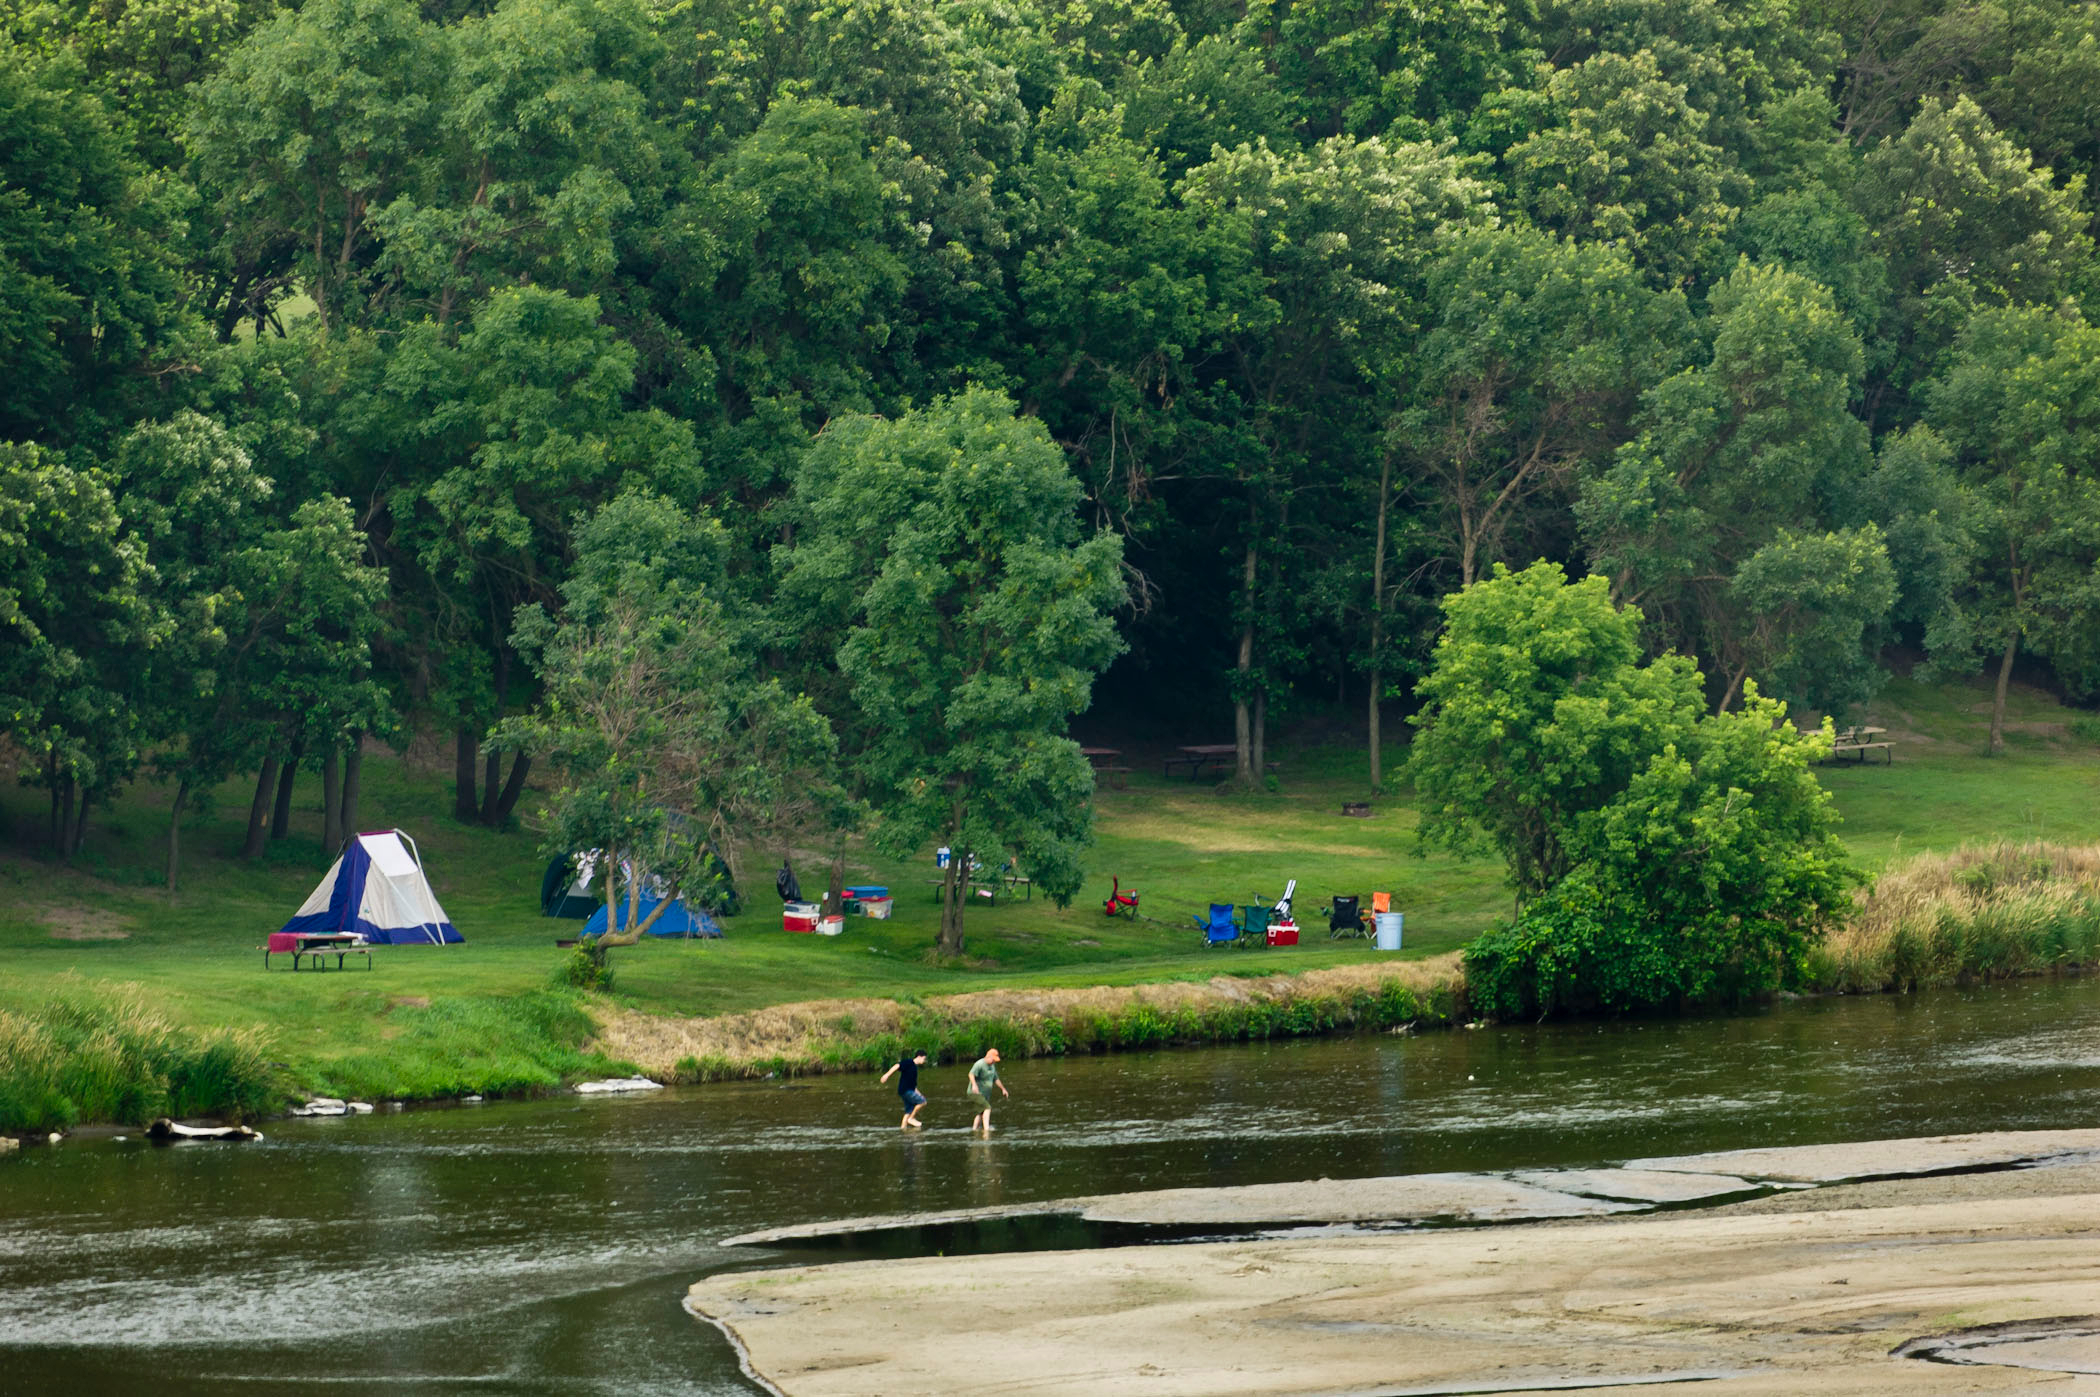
0,979,2100,1397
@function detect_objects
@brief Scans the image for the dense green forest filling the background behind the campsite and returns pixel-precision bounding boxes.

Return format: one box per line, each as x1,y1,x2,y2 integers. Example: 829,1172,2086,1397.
0,0,2100,894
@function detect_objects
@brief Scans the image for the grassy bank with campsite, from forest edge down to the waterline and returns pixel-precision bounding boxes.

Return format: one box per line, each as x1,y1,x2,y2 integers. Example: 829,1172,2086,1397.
0,683,2100,1120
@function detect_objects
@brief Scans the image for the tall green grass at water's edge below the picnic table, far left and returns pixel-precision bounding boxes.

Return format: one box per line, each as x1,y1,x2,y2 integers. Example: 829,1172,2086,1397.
0,994,286,1132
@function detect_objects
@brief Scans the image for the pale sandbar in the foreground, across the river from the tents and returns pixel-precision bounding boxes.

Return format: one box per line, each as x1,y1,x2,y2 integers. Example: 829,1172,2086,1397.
687,1130,2100,1397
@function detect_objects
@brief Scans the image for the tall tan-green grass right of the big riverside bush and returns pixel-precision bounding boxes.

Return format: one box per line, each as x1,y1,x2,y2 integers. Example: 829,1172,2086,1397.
1808,840,2100,994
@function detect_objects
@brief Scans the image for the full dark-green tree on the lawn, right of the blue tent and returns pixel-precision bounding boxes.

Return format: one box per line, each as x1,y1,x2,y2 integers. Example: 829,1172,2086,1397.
783,389,1124,956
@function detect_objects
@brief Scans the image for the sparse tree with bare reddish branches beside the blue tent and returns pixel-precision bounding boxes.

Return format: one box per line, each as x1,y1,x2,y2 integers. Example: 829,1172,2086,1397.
489,494,832,952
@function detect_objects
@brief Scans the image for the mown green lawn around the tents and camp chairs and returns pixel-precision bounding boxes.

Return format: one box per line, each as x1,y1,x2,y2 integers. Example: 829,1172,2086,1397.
0,681,2100,1080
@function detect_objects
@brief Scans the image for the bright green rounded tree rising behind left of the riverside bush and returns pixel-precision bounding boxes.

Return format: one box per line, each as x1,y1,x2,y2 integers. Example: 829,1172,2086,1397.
1407,563,1703,901
